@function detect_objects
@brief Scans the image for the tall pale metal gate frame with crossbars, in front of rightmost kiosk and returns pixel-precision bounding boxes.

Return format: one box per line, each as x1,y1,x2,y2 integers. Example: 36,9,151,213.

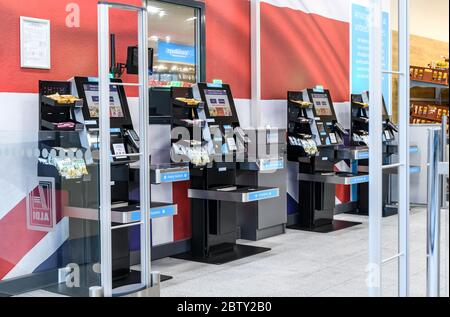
368,0,410,297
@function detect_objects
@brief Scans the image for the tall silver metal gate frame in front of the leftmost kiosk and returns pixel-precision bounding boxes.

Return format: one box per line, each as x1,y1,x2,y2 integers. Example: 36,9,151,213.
98,1,152,297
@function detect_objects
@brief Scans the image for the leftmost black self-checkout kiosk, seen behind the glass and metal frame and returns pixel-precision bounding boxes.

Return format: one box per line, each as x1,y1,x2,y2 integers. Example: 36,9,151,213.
38,77,140,296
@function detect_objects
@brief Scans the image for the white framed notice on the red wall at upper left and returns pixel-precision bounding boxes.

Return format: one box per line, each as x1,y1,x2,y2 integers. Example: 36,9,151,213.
20,17,50,69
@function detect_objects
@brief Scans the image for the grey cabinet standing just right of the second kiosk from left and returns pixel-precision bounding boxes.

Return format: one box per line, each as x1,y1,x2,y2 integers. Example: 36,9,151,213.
236,128,287,241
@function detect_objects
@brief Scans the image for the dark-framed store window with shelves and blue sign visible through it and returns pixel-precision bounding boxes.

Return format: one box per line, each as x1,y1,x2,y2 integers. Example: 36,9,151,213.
147,0,204,88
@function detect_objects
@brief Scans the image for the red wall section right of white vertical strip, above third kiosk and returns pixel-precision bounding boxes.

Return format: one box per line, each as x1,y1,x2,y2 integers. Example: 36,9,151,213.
261,3,350,101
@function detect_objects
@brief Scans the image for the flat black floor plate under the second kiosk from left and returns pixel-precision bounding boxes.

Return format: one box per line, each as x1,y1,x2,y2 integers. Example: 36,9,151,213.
173,244,270,265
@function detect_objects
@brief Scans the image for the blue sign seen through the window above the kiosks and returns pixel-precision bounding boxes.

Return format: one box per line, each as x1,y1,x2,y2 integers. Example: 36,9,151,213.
158,41,196,65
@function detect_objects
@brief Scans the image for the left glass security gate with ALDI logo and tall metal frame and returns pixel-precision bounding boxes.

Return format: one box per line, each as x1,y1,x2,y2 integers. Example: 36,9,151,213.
0,2,159,297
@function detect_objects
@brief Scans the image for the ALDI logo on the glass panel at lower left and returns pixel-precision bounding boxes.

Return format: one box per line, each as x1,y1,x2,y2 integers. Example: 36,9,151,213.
27,177,56,232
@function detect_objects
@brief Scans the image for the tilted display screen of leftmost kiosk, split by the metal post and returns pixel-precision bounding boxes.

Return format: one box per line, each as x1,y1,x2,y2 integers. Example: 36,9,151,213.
84,83,125,118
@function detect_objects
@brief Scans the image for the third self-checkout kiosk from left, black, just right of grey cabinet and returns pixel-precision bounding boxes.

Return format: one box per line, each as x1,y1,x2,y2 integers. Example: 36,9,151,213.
287,87,369,232
